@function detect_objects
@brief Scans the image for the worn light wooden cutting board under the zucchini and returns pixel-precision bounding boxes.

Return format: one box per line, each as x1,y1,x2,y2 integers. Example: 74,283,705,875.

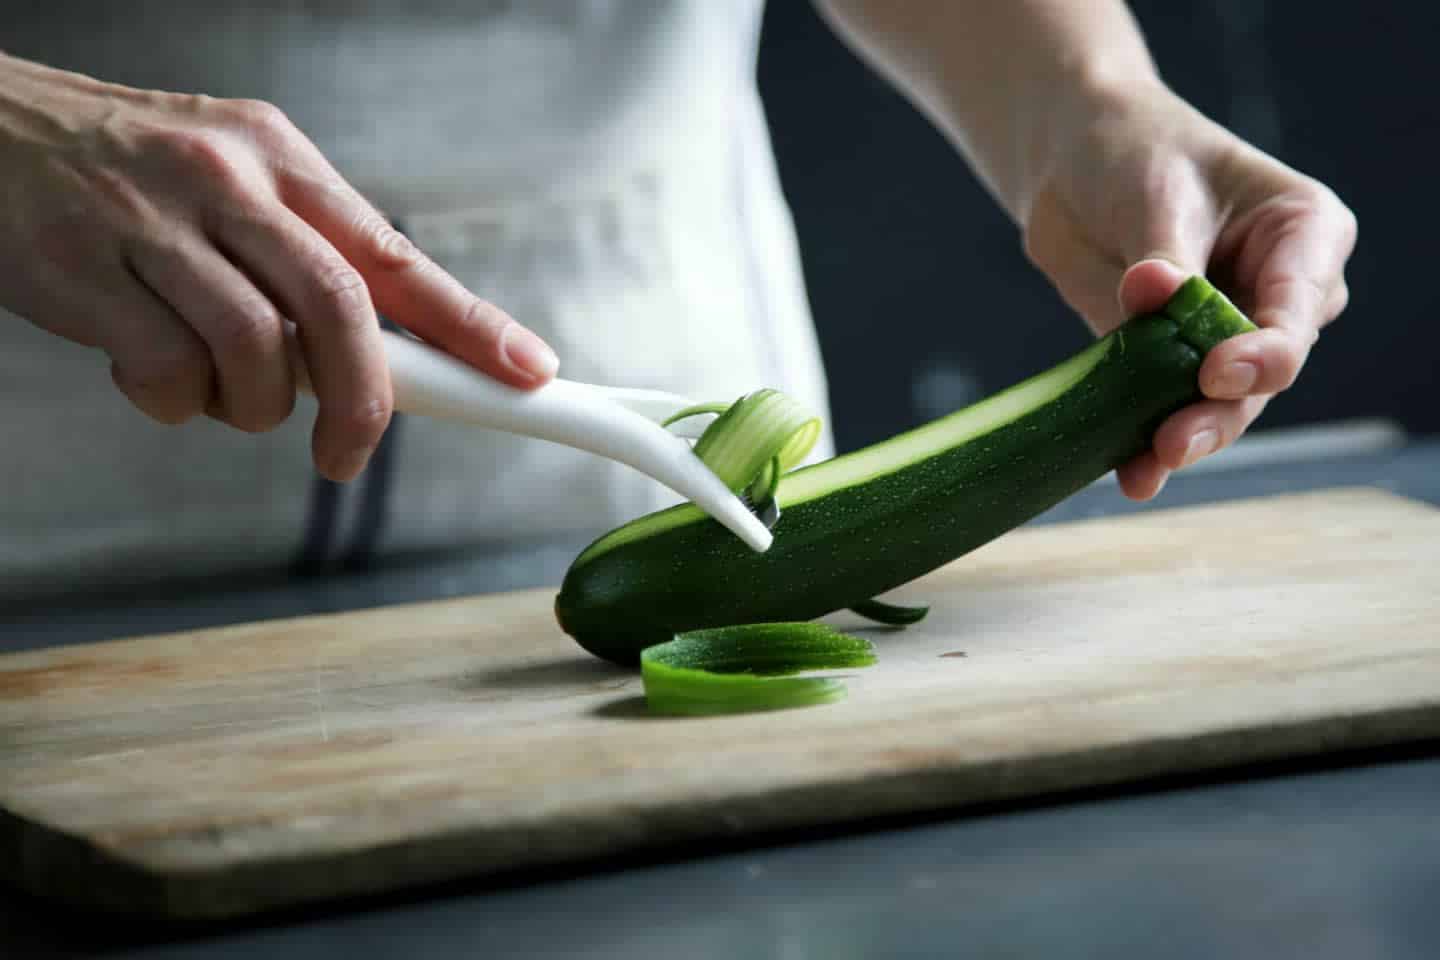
0,489,1440,915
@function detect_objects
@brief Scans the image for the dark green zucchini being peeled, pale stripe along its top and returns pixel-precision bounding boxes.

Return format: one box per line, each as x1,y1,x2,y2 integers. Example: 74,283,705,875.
556,276,1254,665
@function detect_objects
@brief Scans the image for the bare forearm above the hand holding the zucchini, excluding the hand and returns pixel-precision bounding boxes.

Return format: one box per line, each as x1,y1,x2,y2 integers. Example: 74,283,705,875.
816,0,1159,223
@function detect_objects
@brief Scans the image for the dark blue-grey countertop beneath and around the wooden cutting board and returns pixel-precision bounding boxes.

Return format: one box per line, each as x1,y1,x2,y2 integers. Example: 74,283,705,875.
0,439,1440,960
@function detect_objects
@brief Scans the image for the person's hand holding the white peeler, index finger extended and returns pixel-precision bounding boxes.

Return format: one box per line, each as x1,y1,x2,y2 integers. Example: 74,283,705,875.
0,55,557,481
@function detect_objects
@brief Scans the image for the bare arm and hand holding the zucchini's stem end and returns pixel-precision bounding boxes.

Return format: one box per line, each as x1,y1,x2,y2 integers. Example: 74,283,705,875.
816,0,1356,499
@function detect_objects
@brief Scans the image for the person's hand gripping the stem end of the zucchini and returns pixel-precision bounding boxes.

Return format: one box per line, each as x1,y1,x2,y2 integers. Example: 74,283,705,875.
1024,86,1356,499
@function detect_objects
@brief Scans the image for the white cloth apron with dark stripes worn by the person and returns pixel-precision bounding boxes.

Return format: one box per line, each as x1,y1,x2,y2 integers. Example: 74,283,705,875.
0,0,831,599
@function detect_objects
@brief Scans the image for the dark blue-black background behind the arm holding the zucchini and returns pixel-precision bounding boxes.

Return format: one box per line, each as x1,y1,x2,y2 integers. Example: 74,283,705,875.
760,0,1440,449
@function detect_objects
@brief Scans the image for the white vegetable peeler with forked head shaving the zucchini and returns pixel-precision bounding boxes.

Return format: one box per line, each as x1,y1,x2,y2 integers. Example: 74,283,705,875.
289,330,773,553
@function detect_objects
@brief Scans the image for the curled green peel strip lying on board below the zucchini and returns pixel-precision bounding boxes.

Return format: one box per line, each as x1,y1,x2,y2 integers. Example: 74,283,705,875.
639,623,876,715
